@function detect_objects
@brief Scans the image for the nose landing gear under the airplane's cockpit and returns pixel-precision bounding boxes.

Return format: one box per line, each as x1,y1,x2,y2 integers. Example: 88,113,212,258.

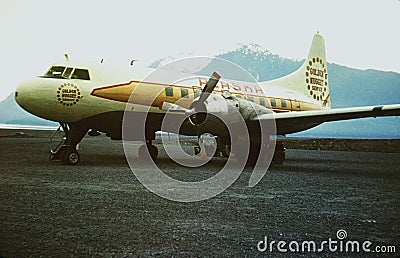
49,123,88,165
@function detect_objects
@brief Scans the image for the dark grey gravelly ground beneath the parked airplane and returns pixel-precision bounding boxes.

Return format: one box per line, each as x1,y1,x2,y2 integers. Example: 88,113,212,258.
0,137,400,257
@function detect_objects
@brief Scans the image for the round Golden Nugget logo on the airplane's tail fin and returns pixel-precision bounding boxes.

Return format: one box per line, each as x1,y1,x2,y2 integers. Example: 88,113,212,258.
305,57,329,101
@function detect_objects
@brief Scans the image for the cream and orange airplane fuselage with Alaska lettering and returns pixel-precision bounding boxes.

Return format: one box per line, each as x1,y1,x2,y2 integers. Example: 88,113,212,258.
15,62,323,123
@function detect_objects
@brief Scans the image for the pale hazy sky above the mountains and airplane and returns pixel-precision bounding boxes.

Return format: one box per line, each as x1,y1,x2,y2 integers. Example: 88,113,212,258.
0,0,400,100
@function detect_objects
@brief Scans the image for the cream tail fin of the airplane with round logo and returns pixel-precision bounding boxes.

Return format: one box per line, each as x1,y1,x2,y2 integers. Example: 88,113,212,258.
266,33,331,108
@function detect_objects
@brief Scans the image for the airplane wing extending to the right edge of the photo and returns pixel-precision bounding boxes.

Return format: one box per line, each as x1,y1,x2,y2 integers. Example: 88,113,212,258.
253,104,400,135
